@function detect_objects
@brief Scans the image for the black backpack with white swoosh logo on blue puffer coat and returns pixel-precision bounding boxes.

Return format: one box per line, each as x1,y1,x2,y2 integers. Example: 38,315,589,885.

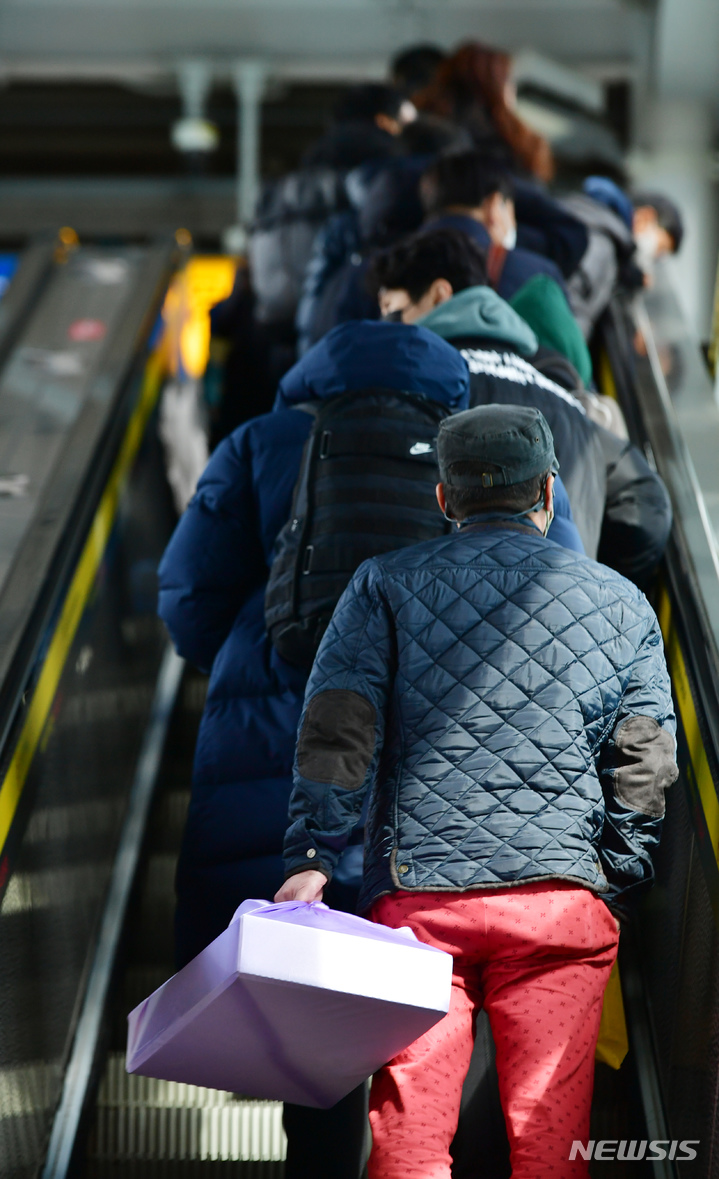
265,389,449,670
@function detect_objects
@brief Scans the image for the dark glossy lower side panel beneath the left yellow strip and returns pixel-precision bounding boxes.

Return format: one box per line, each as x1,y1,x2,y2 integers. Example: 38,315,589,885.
0,415,173,1179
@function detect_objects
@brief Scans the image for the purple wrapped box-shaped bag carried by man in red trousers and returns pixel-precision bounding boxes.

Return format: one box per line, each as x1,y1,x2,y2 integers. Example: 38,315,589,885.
126,901,453,1108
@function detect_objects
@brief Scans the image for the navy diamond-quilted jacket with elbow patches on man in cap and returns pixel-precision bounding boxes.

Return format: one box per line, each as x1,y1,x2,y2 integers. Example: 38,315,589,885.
285,521,677,909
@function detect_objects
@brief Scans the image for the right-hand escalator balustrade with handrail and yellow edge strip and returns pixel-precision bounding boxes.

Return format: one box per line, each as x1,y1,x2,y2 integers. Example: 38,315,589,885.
596,268,719,1177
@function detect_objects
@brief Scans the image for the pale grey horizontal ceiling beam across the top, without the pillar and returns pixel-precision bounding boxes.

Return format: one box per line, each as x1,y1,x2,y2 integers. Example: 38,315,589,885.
0,0,645,83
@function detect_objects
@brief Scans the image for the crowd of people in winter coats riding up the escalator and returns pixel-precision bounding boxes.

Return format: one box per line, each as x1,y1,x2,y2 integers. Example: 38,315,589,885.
160,45,682,1179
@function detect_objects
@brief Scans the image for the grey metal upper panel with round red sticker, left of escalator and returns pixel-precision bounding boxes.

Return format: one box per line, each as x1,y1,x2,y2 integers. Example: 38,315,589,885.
0,248,169,730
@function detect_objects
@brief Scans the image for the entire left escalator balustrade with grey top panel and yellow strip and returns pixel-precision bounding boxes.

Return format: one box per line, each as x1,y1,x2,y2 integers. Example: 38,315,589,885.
0,234,181,1179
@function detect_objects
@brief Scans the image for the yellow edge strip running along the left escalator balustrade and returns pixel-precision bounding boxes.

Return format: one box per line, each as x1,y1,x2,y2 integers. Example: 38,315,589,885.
0,350,165,854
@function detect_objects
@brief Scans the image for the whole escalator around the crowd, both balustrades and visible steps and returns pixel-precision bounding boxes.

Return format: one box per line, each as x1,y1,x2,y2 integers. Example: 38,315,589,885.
0,246,719,1179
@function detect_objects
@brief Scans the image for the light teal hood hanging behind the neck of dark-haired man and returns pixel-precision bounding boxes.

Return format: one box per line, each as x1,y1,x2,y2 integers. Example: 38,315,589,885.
418,284,537,356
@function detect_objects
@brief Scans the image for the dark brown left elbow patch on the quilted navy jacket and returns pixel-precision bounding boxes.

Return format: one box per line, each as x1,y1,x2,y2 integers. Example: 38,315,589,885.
297,689,377,790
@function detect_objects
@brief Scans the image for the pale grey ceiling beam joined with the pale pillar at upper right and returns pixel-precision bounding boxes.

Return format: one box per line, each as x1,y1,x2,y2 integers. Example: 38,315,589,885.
0,0,719,331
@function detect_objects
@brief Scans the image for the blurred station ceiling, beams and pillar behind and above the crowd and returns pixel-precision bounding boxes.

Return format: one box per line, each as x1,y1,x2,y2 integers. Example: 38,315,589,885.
0,0,719,338
